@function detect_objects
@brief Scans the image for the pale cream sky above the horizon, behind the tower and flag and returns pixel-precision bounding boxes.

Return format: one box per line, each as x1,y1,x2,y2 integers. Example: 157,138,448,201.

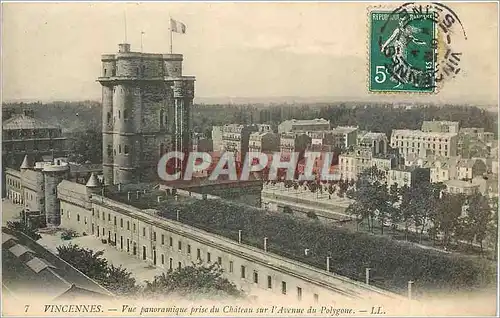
2,2,499,105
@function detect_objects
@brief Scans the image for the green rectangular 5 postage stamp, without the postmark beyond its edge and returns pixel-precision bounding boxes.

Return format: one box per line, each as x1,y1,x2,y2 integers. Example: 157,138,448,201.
369,11,436,93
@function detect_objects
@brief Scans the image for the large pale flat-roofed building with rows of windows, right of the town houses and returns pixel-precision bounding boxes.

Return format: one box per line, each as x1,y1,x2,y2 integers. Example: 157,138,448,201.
391,129,457,157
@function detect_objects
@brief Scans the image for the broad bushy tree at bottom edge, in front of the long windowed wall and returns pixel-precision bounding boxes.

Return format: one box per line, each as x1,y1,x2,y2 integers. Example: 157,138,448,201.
144,263,244,298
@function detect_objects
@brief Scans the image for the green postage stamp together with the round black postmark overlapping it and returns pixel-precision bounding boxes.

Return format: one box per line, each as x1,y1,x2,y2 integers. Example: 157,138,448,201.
369,3,466,93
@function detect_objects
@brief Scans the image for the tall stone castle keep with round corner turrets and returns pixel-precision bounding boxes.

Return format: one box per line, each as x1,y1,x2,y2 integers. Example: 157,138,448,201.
98,43,195,185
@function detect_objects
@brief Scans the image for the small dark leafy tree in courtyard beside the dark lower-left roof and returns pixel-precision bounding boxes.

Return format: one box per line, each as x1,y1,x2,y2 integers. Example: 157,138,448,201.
57,244,108,281
